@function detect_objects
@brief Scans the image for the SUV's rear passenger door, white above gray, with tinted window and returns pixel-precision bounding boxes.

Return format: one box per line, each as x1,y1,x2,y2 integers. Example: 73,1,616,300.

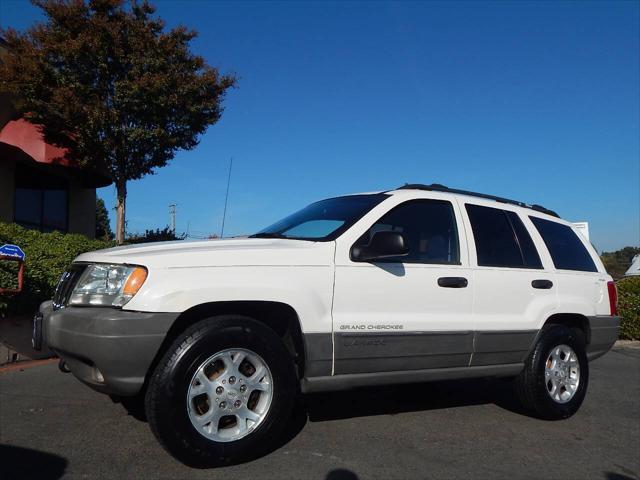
461,201,557,366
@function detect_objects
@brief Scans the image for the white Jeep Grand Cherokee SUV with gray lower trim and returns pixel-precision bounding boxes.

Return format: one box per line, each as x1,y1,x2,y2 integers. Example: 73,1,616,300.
34,185,620,465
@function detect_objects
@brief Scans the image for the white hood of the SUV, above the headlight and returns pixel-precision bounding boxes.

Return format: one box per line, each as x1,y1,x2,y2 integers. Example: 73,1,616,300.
76,238,335,268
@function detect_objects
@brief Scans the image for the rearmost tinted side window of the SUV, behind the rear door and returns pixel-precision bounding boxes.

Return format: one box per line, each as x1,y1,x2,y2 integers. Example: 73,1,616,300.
529,217,598,272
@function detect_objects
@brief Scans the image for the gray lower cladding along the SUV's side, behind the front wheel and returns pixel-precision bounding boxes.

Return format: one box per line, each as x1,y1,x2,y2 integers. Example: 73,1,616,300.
301,316,620,392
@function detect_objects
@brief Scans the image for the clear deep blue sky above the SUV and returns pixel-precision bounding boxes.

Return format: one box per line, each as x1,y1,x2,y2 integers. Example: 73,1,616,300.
0,0,640,251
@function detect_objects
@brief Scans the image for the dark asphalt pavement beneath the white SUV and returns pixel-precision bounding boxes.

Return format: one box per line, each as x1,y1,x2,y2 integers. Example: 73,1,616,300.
0,347,640,480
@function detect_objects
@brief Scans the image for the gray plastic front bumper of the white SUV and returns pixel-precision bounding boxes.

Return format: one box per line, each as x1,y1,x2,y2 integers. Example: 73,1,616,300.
34,302,178,396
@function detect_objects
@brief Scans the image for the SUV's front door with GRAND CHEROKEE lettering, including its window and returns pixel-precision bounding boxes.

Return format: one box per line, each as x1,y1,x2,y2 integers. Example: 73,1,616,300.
333,194,473,374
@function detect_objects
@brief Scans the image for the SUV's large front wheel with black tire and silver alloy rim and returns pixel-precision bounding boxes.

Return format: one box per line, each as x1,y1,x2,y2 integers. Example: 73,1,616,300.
145,315,297,467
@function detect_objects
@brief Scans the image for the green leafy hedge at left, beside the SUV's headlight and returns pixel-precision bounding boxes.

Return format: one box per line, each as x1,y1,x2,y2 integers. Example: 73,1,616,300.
0,223,113,313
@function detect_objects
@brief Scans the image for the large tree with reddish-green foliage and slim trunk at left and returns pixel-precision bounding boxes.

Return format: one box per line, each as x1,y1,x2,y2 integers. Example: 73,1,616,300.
0,0,236,244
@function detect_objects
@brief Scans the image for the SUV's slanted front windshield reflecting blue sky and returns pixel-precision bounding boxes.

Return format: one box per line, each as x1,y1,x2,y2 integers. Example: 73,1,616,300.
251,193,387,241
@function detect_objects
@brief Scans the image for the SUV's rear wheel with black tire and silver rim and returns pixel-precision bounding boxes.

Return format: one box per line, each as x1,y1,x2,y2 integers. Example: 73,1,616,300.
514,325,589,420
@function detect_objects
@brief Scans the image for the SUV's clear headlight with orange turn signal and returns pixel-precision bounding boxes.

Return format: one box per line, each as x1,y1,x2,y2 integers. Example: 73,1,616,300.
69,264,147,307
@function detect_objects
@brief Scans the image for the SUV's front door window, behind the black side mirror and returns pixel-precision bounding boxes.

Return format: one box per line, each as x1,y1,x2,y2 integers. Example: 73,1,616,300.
356,200,460,265
